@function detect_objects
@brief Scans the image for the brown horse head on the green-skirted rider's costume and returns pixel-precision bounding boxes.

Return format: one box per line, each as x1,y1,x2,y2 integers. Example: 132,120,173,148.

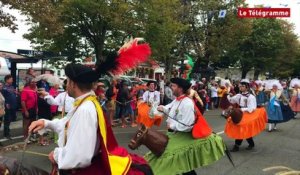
128,125,169,157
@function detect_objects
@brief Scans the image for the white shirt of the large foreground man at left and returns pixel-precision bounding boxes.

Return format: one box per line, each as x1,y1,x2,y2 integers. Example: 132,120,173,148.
45,92,100,169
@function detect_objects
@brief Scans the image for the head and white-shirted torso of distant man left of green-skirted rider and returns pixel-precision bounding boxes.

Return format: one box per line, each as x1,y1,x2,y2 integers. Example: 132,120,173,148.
143,81,160,105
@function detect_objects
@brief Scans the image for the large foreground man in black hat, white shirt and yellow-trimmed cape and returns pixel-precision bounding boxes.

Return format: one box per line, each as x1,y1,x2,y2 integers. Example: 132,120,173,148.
29,64,130,175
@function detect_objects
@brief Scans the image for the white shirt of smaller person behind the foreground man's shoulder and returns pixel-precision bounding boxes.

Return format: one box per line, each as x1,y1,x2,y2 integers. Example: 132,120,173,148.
45,92,74,113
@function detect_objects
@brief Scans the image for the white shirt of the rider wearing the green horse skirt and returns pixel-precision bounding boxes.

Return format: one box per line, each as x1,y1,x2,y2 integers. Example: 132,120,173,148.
164,97,195,132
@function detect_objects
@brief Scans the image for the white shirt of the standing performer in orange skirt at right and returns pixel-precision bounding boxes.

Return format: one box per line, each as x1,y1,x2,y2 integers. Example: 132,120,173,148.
227,94,257,113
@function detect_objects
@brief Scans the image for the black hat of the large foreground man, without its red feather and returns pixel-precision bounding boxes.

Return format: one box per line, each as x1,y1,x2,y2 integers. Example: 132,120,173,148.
65,63,99,83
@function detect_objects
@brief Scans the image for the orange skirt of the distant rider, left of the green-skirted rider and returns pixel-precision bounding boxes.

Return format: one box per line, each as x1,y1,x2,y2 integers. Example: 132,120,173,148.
136,102,162,128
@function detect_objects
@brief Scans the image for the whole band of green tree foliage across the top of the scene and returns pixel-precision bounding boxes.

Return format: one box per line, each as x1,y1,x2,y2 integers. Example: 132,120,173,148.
0,0,300,77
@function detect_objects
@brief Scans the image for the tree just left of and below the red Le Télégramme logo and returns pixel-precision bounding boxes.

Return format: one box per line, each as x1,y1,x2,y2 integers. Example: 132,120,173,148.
182,0,248,78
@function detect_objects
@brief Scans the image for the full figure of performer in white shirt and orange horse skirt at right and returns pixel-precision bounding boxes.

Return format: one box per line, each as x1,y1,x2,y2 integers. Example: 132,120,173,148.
225,79,267,152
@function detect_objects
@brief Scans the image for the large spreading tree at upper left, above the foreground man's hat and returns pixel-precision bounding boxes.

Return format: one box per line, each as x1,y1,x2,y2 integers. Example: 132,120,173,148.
2,0,138,65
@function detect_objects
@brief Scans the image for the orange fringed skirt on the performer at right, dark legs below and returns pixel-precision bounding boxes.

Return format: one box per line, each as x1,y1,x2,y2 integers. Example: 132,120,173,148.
224,108,268,139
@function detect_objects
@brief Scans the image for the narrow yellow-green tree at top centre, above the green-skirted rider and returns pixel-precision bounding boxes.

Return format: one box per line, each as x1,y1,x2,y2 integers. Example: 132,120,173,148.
142,0,186,78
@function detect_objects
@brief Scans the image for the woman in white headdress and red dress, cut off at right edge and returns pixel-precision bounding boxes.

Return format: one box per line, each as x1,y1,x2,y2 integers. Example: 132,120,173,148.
290,79,300,113
